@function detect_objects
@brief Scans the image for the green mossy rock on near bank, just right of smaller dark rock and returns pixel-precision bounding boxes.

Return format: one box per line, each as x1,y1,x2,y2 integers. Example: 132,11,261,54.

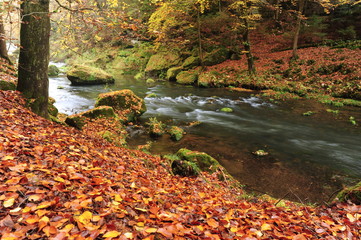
177,148,220,172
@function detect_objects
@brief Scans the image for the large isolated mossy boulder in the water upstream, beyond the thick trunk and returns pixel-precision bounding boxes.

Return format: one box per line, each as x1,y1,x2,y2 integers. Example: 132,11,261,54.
67,65,114,85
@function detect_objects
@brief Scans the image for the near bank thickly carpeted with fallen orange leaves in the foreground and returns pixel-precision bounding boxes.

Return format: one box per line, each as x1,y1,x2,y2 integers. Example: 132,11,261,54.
0,88,361,240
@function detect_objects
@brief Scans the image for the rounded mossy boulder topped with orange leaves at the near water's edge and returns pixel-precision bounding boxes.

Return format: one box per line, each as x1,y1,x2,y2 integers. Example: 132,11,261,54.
95,89,147,122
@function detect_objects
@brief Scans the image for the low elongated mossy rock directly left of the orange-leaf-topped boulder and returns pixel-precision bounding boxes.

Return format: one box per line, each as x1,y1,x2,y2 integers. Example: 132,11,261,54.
65,106,118,129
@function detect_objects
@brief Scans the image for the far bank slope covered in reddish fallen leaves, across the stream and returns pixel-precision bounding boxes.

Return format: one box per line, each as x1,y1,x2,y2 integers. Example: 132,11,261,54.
202,34,361,107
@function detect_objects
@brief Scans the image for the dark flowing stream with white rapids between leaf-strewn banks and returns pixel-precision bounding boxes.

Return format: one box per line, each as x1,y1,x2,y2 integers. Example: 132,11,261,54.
50,72,361,202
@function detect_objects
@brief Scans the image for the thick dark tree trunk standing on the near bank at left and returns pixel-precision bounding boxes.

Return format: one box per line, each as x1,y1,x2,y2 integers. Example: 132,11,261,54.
17,0,50,118
